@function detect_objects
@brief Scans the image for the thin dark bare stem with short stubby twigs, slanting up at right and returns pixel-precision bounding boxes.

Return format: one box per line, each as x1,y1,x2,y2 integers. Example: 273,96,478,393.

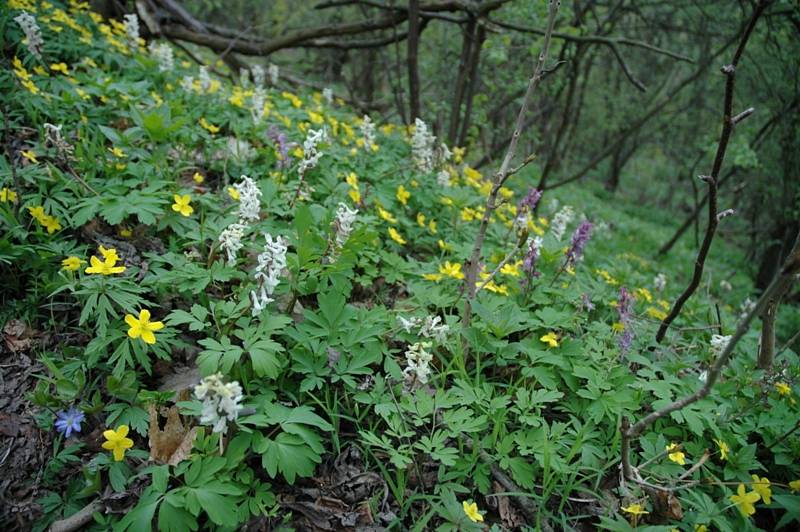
656,0,769,343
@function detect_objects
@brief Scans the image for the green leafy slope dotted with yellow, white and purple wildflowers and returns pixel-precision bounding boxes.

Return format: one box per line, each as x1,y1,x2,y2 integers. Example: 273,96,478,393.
0,0,800,530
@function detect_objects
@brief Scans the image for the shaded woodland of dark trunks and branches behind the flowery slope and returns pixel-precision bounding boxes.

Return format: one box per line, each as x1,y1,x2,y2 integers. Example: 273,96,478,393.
104,0,800,288
